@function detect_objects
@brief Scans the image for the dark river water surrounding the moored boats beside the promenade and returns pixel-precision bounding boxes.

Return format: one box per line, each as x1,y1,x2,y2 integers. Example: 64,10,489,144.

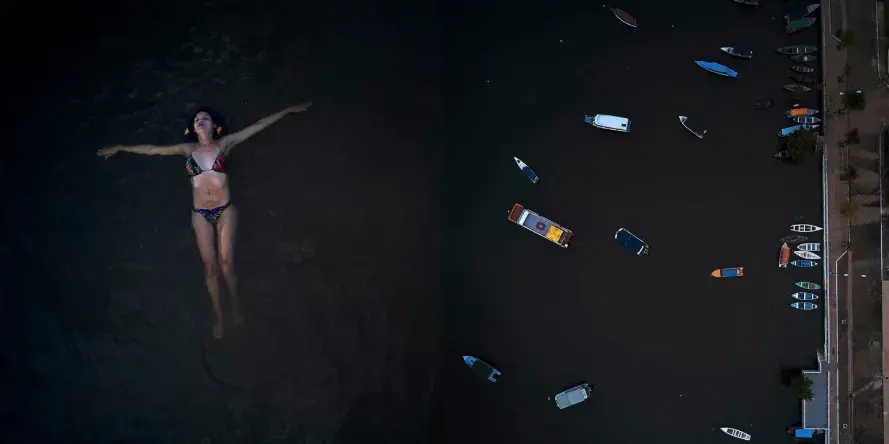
446,0,823,443
